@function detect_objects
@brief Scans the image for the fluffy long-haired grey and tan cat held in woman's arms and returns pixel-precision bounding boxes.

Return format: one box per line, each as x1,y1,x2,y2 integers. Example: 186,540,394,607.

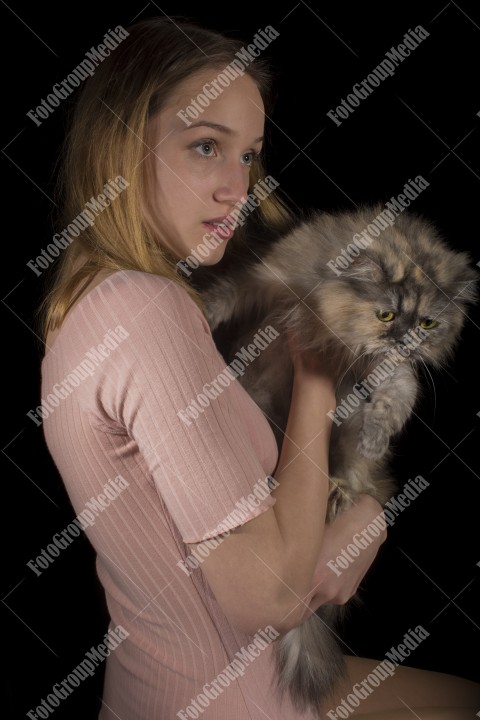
198,205,476,711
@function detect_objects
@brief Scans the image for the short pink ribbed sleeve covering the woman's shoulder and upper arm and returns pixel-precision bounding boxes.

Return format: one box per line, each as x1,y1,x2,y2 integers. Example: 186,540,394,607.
79,271,277,543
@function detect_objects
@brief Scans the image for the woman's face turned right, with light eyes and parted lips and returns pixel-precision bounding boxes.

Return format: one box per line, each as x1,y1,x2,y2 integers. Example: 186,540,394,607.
146,68,265,265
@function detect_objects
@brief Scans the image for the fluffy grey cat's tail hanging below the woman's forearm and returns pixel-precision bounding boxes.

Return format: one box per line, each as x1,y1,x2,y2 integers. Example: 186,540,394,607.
276,606,346,717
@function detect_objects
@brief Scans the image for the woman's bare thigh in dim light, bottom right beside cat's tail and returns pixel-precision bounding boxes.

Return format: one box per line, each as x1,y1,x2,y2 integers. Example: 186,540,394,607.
322,657,480,720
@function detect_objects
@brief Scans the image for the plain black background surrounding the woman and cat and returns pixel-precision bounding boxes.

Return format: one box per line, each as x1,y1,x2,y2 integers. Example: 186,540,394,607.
1,0,480,720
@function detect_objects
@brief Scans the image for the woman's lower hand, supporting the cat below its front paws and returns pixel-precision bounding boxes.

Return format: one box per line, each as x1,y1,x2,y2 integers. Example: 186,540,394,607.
309,495,387,611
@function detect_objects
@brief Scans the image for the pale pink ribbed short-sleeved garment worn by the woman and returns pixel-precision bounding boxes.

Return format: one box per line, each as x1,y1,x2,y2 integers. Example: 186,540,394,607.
42,271,316,720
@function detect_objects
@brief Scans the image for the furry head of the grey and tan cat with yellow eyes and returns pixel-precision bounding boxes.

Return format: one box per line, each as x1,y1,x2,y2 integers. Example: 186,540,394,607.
317,210,476,365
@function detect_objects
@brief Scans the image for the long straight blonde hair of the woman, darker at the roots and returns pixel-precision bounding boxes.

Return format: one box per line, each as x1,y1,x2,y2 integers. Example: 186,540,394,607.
39,17,289,339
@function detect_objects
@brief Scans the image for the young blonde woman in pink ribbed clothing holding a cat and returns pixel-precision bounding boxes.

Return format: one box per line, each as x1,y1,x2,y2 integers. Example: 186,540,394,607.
42,11,479,720
